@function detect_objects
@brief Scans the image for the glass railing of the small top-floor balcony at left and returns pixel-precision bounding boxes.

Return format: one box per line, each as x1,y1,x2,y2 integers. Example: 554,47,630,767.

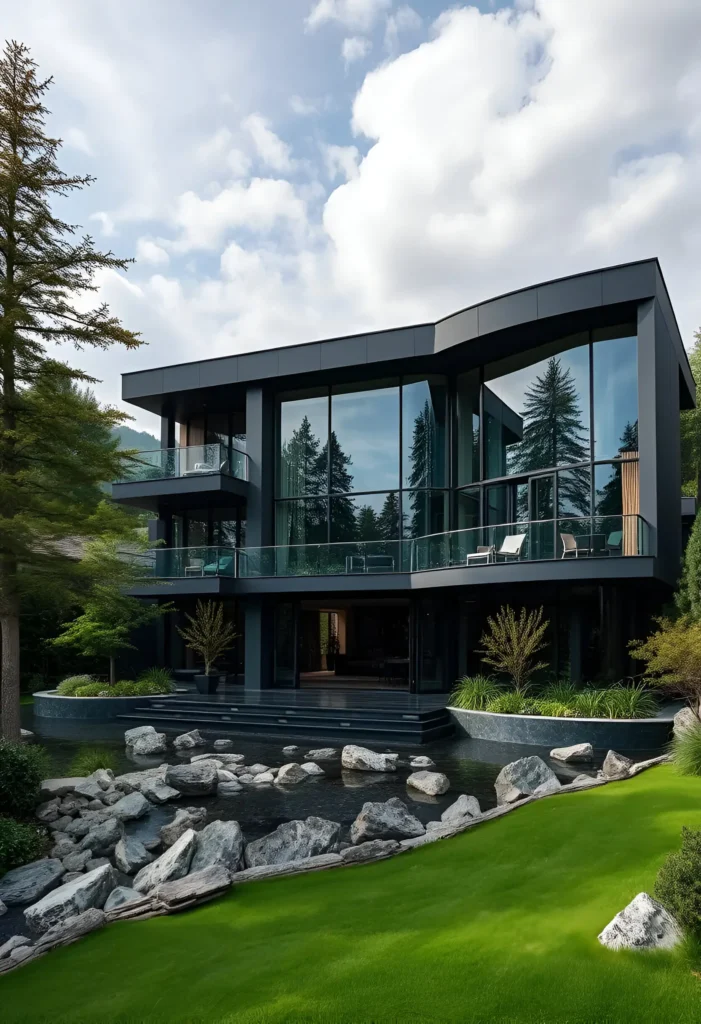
115,444,249,483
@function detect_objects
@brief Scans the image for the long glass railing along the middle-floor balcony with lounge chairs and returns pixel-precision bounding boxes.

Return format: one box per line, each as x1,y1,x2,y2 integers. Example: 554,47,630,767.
141,515,654,580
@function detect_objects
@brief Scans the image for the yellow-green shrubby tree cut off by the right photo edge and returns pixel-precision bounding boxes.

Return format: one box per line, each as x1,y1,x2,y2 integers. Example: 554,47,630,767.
630,614,701,717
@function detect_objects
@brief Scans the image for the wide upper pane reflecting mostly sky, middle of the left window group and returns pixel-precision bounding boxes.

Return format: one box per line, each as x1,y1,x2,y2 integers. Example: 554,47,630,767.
331,381,399,494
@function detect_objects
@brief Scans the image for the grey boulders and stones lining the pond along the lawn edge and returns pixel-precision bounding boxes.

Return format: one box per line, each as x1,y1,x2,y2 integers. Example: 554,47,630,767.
0,726,664,972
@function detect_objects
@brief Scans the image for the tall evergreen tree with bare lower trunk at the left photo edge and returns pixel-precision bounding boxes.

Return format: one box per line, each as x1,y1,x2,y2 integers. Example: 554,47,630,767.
0,42,140,739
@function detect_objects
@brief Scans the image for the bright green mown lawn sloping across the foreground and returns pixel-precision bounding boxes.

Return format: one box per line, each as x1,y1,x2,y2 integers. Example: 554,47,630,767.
0,766,701,1024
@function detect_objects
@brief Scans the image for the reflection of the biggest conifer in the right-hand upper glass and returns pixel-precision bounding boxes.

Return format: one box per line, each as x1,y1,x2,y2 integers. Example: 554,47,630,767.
509,356,589,516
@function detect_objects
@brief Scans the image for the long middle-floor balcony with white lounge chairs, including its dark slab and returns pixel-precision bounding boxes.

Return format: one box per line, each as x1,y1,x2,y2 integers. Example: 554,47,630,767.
128,515,655,592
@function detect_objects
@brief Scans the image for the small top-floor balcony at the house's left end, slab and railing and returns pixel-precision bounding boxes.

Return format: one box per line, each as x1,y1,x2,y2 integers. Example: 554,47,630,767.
112,444,249,511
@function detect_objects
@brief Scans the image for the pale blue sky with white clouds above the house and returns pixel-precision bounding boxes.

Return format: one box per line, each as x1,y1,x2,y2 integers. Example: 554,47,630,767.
0,0,701,429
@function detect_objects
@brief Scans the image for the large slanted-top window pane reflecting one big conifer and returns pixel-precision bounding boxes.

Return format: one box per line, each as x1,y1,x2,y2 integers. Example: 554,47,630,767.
484,335,590,477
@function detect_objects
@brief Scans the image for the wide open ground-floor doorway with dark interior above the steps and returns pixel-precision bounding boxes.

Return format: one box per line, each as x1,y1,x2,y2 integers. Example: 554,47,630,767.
275,598,410,690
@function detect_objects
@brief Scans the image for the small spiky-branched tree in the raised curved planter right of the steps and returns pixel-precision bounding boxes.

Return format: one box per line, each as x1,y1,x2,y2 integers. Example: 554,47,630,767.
480,604,550,693
